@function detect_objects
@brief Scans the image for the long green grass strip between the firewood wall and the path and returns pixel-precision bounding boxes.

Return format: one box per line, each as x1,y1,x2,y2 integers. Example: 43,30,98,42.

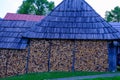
0,72,108,80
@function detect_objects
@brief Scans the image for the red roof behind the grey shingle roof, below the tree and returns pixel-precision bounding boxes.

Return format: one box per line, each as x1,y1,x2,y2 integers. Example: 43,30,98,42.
4,13,44,21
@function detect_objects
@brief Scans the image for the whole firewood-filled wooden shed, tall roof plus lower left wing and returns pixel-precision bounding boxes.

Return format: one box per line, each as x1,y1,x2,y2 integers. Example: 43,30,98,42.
0,0,120,77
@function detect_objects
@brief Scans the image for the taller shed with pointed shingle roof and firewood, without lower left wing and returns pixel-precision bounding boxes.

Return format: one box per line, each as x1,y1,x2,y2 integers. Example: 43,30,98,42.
23,0,120,71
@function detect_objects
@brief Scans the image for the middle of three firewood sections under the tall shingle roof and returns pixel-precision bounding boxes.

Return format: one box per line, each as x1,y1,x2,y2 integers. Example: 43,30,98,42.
50,40,73,71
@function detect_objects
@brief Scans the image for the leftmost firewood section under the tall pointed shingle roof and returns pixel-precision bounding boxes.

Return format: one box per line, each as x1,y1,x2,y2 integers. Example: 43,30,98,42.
29,40,49,72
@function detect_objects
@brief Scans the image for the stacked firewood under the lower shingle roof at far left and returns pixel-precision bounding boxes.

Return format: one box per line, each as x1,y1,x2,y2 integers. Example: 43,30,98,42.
0,49,27,77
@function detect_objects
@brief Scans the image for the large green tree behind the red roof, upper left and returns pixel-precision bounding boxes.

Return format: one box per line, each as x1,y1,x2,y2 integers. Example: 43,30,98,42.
17,0,55,15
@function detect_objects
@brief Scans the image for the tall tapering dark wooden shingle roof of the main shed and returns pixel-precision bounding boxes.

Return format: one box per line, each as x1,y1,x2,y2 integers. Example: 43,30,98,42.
24,0,120,40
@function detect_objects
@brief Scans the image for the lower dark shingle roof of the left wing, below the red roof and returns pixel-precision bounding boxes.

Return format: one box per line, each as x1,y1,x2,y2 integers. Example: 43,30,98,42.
0,20,36,49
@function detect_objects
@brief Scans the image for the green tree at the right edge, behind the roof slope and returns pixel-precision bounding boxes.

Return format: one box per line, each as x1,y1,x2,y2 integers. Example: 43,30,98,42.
105,6,120,22
